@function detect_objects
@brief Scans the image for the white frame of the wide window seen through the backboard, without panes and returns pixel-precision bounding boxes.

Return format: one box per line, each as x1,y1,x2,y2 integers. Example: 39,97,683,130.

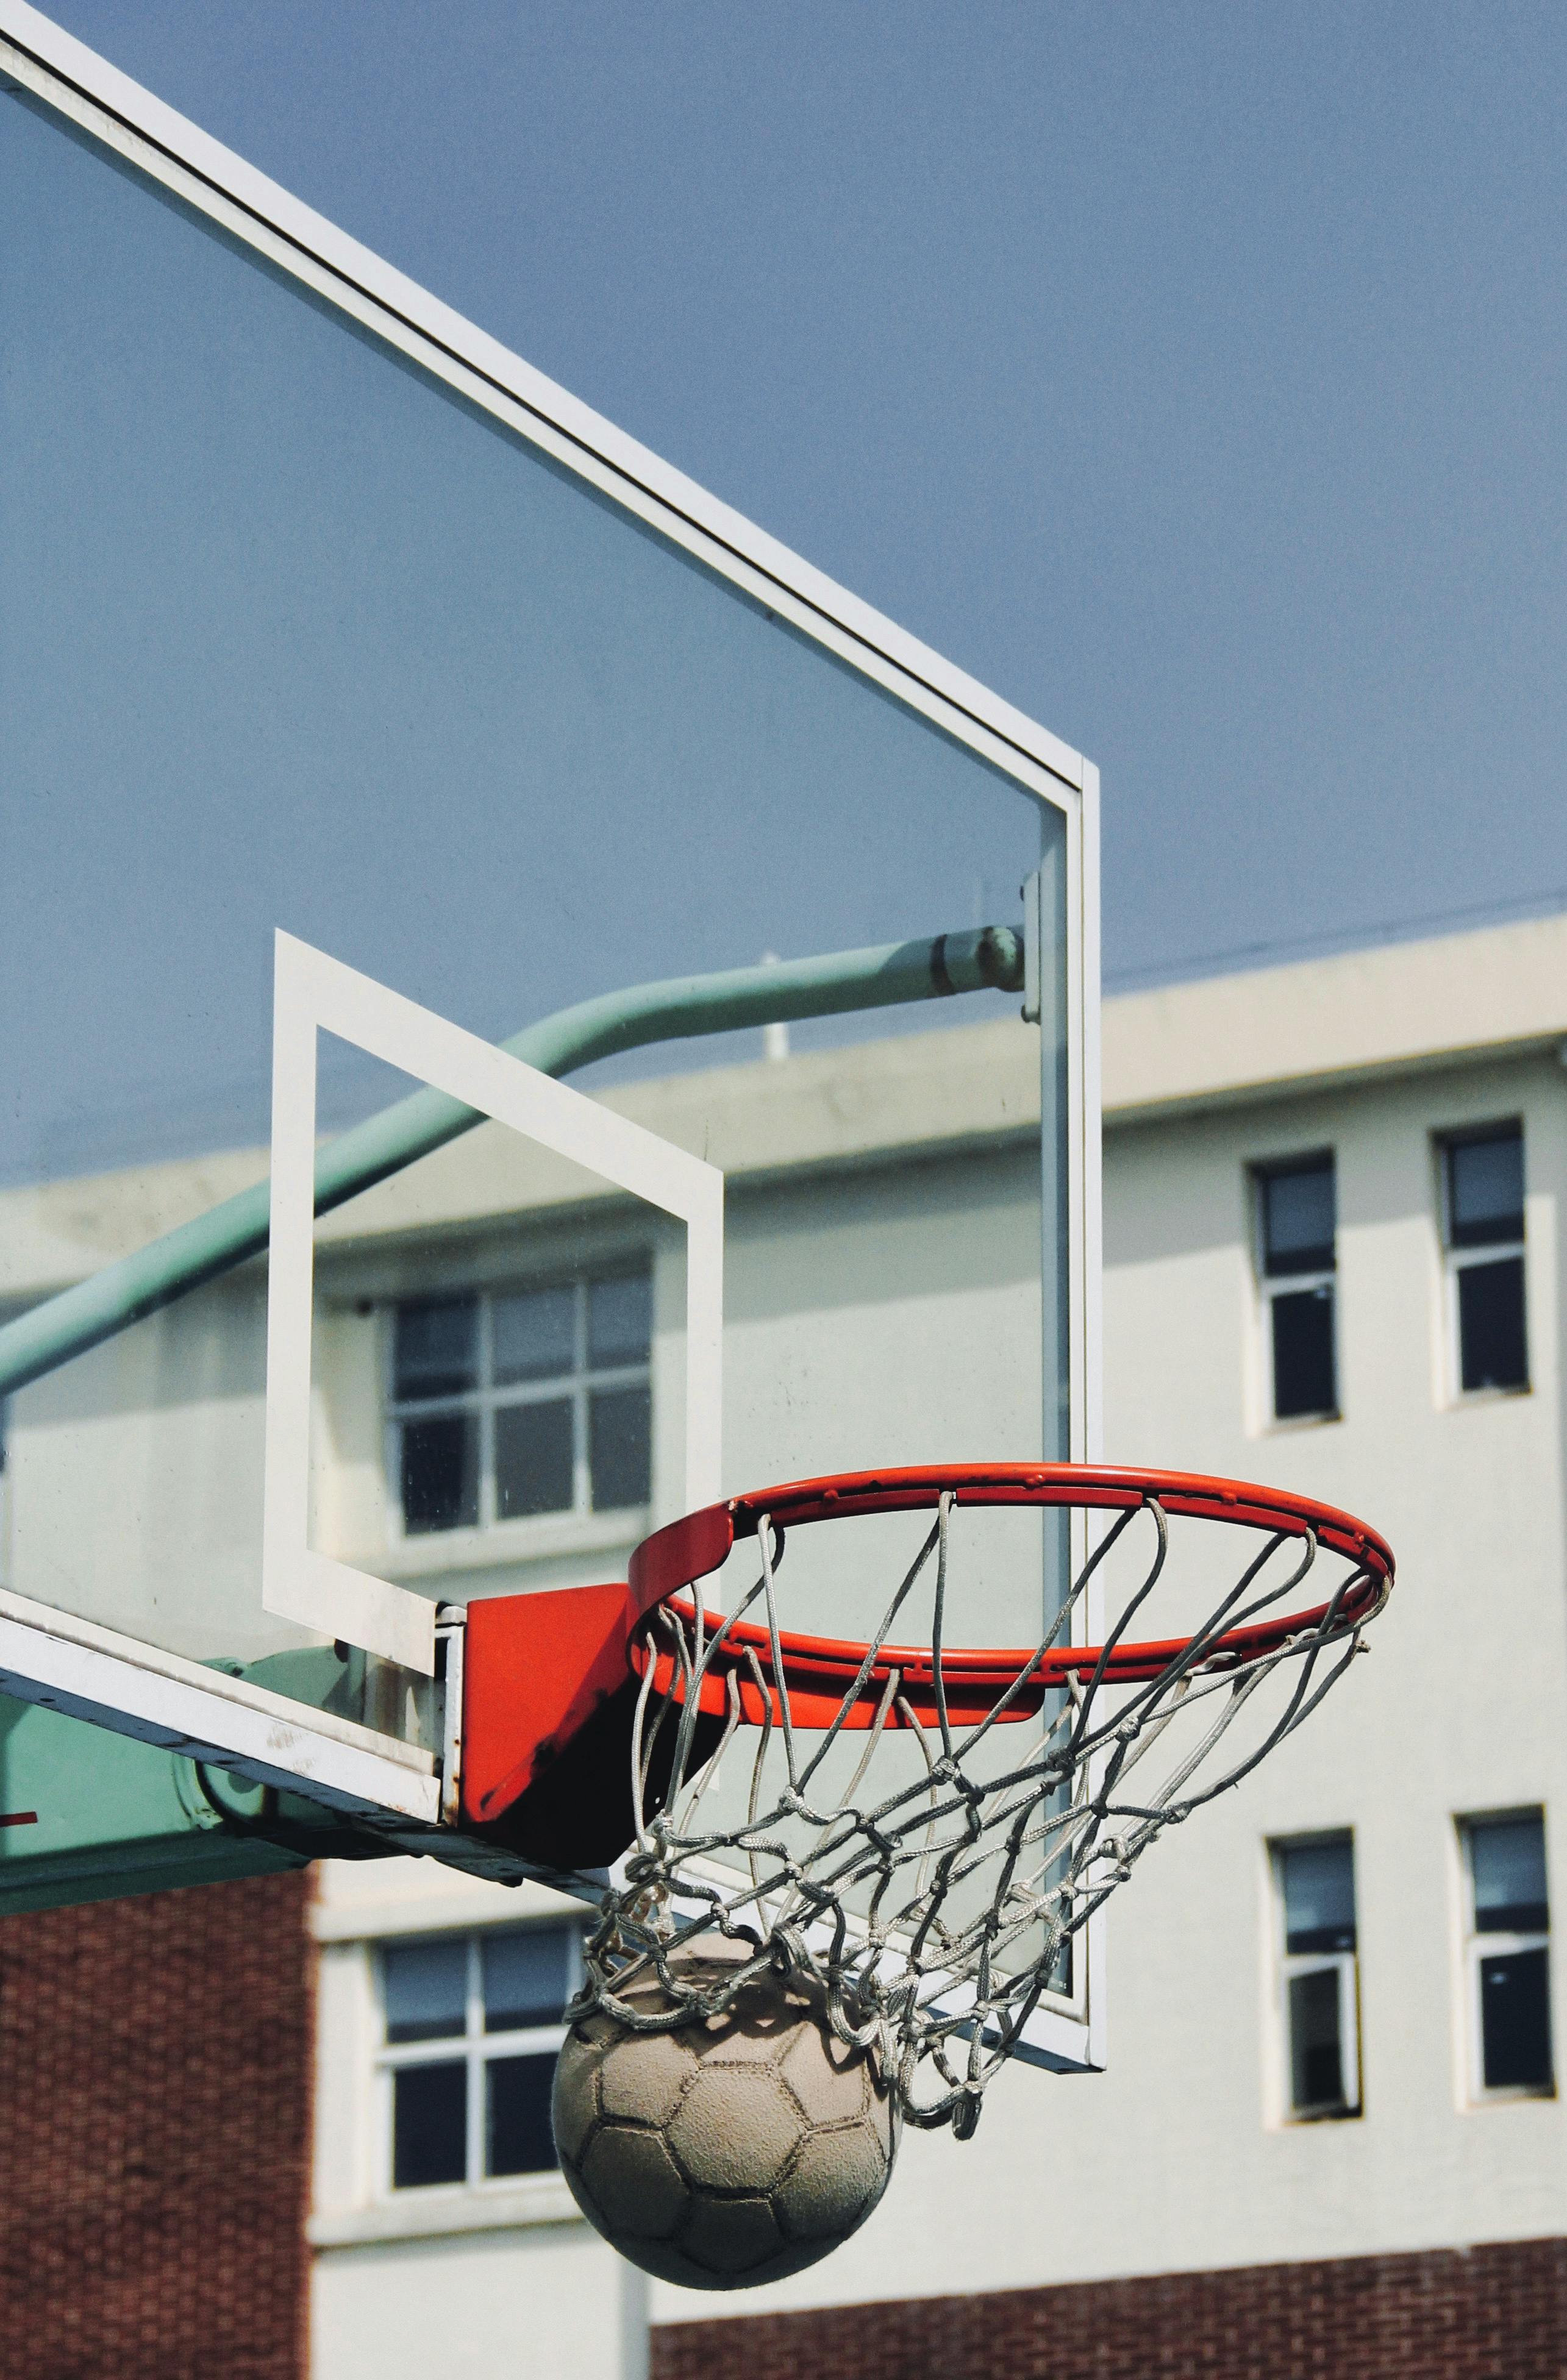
381,1252,655,1552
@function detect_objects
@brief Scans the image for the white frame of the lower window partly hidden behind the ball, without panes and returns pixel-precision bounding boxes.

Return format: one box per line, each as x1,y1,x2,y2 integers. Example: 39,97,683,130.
366,1919,584,2206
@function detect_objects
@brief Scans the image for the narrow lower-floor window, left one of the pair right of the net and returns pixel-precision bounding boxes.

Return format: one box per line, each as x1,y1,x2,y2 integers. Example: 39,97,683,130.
1274,1835,1360,2123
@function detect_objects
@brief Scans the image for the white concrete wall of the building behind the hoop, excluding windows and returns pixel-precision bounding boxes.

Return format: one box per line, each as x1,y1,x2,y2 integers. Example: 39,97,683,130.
12,926,1567,2380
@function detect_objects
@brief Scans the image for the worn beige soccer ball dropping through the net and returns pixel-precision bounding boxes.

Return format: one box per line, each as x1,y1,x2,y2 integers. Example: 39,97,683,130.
552,1940,898,2290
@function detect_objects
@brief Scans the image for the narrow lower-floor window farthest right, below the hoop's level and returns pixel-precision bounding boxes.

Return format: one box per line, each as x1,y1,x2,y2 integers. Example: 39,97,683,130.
1462,1811,1555,2099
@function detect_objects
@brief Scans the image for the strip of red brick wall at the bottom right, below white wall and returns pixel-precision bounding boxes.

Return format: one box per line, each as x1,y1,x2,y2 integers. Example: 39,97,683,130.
652,2240,1567,2380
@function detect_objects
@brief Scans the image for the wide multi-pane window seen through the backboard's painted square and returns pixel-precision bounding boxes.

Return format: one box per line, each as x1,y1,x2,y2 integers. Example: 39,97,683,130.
391,1274,652,1537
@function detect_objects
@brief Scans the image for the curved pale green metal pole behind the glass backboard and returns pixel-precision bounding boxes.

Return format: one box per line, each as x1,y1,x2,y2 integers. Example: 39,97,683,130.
0,926,1024,1397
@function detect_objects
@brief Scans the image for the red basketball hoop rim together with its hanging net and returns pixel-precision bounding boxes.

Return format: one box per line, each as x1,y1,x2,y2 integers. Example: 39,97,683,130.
571,1464,1393,2137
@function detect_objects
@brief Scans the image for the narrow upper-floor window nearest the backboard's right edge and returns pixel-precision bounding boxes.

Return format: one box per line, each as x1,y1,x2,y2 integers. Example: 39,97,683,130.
1255,1156,1338,1421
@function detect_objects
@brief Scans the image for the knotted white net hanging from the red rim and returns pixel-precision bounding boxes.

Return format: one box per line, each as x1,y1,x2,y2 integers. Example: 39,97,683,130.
571,1495,1386,2137
